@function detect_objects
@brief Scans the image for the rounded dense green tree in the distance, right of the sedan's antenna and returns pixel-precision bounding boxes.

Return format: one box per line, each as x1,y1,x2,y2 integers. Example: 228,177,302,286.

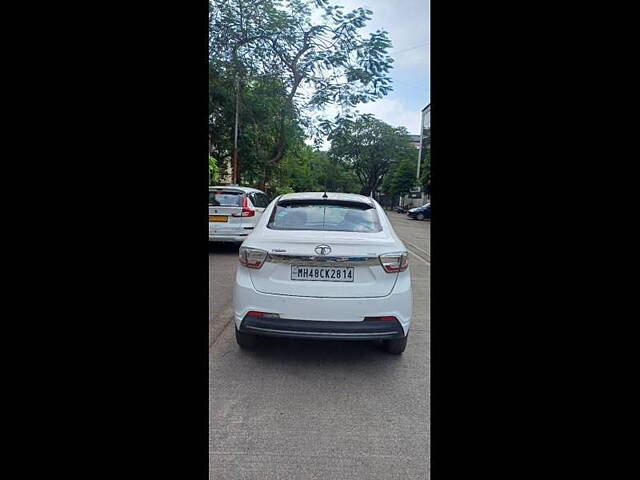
329,115,416,195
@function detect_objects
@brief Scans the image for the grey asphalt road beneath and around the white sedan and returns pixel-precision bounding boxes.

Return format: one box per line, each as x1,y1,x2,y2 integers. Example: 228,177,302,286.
209,213,431,480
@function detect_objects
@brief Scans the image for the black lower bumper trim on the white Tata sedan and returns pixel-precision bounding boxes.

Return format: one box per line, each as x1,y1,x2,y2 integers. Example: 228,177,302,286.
239,316,404,340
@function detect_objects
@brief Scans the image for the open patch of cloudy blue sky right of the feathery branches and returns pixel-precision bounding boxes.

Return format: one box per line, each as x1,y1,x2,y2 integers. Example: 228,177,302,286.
312,0,431,134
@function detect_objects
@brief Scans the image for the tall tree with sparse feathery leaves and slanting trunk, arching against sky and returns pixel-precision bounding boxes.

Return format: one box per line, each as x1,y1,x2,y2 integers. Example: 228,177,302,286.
209,0,393,174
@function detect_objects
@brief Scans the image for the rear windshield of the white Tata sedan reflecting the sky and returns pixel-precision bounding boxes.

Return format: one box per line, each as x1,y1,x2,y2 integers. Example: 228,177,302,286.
267,202,382,232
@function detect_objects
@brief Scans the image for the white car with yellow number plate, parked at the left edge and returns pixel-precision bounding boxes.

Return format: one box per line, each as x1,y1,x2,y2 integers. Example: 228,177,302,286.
209,186,269,243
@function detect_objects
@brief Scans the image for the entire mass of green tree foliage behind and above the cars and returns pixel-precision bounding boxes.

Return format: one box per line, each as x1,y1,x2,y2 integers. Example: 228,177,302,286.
209,0,430,195
